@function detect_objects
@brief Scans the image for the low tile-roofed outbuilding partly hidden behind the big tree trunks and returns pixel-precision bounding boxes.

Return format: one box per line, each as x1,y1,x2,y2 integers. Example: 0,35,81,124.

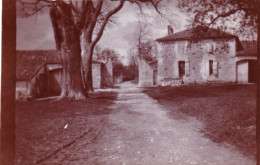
16,50,112,99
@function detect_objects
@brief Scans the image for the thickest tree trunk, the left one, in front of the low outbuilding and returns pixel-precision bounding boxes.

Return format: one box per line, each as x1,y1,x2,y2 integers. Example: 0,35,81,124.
50,4,87,100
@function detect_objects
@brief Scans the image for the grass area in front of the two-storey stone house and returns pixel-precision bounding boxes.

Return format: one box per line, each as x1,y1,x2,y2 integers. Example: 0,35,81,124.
144,84,256,158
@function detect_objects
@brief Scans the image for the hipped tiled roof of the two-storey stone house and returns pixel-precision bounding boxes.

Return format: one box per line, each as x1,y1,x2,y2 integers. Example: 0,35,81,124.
156,27,237,42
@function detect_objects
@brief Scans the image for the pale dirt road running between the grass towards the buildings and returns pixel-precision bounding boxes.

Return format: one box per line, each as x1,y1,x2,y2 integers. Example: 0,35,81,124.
42,83,256,165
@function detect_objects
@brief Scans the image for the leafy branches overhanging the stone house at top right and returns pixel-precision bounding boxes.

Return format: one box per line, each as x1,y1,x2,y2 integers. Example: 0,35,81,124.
178,0,259,39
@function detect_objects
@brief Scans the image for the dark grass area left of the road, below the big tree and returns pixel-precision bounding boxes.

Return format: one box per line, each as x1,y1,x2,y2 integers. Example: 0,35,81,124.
15,92,116,164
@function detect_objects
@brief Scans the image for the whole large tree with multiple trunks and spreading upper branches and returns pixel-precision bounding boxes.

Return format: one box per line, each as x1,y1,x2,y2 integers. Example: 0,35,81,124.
18,0,164,99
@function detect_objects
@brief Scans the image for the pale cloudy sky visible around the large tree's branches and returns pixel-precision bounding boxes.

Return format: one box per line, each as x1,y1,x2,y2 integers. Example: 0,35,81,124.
17,1,187,64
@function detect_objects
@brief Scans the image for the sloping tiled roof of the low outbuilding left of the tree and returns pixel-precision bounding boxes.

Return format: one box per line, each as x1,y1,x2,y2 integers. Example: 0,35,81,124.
16,50,60,80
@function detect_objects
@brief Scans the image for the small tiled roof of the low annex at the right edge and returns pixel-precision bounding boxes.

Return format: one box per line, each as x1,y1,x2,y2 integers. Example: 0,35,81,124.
239,41,257,56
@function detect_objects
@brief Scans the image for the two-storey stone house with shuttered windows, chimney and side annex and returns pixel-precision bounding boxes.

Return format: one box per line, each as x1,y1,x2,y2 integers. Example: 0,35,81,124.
147,27,257,86
